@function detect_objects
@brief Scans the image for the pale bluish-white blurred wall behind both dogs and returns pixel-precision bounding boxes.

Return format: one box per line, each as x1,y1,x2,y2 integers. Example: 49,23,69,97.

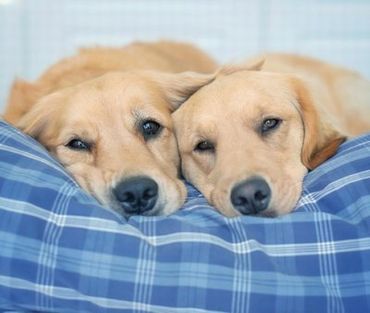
0,0,370,110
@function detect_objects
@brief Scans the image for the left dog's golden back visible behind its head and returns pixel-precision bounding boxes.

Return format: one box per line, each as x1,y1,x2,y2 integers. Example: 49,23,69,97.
4,41,216,124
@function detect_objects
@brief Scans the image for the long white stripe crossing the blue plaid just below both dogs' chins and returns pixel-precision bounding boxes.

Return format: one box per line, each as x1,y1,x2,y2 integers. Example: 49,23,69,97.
0,198,370,256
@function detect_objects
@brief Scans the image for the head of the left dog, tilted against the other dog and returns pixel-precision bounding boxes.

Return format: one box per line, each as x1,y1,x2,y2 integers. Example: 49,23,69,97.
17,71,214,216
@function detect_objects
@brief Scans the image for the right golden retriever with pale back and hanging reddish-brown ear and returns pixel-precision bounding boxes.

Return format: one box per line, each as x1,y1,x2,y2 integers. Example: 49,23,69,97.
173,54,370,216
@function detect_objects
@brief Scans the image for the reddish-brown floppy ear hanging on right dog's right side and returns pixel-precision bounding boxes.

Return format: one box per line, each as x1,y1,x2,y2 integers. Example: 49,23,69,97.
293,79,346,170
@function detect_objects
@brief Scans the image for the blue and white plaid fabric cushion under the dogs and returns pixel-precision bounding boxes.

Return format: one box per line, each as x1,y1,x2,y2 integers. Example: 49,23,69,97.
0,118,370,313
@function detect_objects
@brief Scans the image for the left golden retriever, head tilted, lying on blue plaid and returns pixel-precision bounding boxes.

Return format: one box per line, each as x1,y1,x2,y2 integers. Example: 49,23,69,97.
5,43,217,216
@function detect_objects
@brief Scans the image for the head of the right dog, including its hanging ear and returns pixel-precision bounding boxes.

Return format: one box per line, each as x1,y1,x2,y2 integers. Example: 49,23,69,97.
173,70,344,216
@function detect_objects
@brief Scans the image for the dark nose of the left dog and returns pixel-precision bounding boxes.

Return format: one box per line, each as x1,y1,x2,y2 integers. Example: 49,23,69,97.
113,176,158,215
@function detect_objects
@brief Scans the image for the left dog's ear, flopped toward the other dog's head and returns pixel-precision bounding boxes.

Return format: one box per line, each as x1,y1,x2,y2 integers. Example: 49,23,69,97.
157,72,217,111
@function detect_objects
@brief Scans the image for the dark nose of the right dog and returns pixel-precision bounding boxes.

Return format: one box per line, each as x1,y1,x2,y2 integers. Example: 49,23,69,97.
231,177,271,215
